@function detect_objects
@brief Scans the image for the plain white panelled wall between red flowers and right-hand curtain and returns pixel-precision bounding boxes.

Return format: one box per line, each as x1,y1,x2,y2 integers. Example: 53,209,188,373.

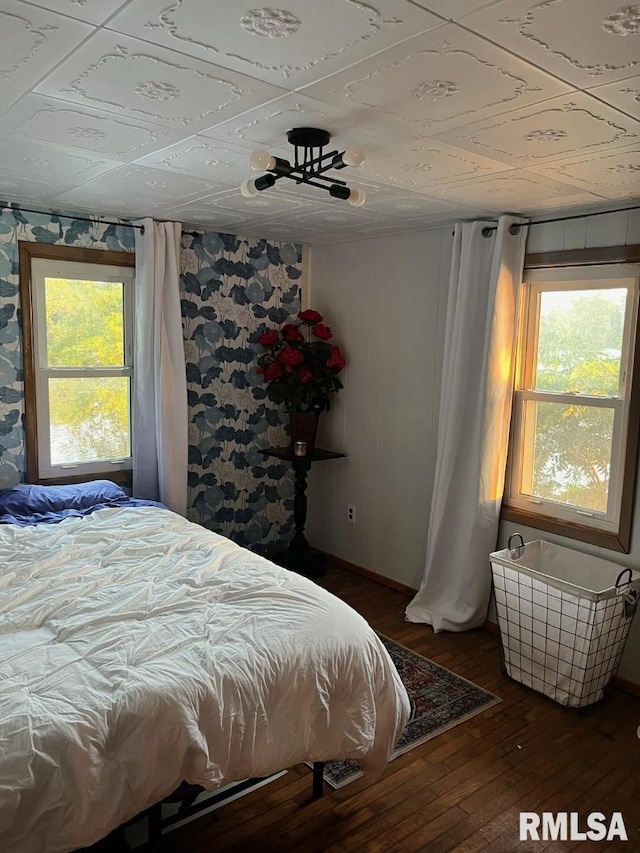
307,226,453,587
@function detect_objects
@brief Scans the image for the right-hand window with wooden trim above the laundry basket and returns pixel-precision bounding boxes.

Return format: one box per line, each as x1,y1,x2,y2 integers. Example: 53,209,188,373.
503,246,640,551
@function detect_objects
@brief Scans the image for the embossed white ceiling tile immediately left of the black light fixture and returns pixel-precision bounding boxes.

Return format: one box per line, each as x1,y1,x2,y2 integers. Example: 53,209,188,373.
136,136,251,186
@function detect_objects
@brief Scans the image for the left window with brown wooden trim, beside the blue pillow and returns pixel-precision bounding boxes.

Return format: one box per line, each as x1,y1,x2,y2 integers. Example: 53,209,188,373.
20,243,134,482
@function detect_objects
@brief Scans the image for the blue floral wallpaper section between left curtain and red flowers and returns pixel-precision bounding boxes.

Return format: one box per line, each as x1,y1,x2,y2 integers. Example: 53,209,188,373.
181,232,302,546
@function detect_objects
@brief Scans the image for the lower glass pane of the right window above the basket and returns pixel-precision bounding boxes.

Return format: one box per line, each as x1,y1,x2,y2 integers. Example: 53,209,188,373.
522,401,614,513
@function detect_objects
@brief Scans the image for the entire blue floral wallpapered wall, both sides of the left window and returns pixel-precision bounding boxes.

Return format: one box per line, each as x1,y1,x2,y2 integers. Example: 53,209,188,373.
0,205,302,546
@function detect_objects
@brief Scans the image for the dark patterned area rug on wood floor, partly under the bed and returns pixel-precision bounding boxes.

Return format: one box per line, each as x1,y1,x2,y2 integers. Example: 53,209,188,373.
324,634,502,788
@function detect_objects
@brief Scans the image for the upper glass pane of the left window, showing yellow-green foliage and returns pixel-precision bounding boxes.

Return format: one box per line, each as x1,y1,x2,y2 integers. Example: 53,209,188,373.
45,277,124,367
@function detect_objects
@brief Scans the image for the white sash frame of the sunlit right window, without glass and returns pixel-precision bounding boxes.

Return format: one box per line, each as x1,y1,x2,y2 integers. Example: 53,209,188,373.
504,263,640,547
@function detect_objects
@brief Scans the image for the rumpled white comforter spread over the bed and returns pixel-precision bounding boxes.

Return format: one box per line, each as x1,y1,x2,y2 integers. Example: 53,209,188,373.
0,507,408,853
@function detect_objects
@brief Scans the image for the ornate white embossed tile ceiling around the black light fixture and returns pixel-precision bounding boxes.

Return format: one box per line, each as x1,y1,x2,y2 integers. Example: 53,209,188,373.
0,0,640,243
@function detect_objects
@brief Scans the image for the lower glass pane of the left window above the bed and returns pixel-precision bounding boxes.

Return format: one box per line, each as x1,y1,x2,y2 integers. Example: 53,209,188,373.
49,376,131,465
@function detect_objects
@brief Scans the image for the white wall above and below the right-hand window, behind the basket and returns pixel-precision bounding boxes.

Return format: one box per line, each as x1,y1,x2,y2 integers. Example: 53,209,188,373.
500,210,640,684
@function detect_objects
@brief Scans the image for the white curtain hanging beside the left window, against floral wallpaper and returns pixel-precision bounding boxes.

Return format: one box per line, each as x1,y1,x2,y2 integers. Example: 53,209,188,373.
133,219,188,515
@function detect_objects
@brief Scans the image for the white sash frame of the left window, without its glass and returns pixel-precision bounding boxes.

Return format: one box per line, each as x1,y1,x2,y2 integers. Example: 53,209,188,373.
31,257,135,479
